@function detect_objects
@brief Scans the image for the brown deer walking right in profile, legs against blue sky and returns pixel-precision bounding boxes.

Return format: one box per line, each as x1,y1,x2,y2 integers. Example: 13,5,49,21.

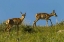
33,10,57,27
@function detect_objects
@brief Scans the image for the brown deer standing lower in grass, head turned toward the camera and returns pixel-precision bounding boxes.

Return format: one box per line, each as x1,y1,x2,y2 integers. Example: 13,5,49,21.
5,12,26,32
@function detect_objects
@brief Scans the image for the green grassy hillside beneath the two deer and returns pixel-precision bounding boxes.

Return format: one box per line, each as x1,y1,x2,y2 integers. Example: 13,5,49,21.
0,22,64,42
